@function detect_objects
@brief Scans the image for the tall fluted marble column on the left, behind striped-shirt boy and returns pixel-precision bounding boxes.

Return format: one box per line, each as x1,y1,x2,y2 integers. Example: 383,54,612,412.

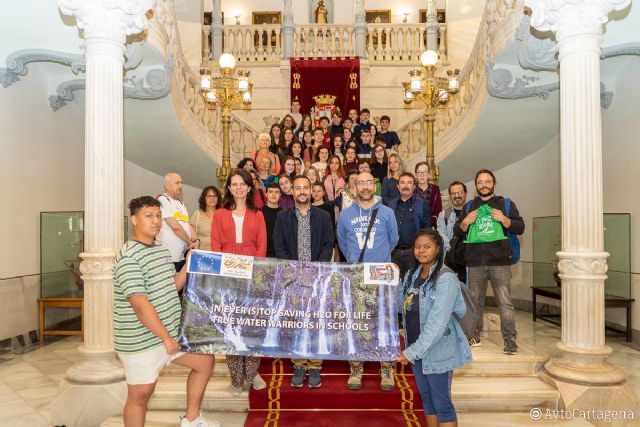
52,0,152,427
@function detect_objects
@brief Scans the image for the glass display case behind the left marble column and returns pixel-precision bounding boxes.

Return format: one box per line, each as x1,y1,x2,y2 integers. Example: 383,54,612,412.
40,211,128,299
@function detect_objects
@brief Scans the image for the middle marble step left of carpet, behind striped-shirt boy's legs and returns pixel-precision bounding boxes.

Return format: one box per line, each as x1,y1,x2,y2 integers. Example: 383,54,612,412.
149,375,249,412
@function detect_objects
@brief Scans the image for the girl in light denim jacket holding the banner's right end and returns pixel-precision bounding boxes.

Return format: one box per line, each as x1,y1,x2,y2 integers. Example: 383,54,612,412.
397,229,471,427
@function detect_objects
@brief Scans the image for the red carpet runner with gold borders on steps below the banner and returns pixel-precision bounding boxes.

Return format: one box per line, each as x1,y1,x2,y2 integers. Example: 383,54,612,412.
245,358,424,427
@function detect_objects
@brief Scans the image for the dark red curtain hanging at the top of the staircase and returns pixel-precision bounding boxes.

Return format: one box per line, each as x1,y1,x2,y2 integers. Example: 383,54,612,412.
290,58,360,118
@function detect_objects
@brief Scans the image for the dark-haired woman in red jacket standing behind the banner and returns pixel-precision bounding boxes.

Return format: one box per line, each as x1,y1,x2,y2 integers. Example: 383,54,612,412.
211,169,267,395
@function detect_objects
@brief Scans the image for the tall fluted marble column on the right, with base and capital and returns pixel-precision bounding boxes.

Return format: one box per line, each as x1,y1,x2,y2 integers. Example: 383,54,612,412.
525,0,638,413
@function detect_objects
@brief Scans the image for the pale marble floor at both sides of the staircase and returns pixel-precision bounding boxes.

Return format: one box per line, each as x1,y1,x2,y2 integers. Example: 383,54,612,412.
0,312,640,427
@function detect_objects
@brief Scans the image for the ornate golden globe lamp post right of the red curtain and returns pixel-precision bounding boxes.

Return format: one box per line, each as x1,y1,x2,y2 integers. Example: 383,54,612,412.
402,50,460,184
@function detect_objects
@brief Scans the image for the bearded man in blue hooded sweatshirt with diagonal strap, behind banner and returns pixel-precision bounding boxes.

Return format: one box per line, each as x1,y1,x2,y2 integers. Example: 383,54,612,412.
337,172,398,390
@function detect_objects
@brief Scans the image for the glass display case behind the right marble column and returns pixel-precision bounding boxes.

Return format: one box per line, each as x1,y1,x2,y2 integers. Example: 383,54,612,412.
533,213,631,298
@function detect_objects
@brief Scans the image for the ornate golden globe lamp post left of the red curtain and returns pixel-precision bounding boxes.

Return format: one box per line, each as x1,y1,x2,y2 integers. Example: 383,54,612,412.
200,53,253,186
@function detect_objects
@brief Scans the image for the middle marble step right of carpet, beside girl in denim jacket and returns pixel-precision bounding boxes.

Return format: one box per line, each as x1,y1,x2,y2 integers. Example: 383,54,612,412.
451,376,560,412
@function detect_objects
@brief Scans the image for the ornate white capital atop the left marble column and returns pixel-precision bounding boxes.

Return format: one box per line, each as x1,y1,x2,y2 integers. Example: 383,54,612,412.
58,0,153,45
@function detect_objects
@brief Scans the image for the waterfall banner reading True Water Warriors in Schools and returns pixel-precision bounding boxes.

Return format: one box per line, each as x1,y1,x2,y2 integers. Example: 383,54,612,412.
178,251,400,361
